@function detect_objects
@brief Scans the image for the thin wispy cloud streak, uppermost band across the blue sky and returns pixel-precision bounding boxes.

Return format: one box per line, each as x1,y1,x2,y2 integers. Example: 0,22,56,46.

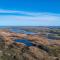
0,9,60,16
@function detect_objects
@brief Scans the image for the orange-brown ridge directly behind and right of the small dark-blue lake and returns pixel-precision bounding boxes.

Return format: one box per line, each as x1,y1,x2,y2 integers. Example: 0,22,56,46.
27,35,49,45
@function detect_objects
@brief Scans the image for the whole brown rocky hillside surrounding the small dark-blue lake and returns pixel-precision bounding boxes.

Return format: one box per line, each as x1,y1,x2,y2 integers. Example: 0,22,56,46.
0,30,60,60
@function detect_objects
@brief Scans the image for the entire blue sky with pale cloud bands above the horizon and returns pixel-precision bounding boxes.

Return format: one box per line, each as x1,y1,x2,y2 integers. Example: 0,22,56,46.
0,0,60,26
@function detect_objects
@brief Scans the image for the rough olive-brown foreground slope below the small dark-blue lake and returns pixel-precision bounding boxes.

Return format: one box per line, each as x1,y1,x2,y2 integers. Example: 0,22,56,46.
0,44,59,60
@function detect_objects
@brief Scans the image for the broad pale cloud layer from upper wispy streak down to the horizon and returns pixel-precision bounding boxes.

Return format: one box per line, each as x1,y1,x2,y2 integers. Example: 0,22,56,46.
0,9,60,26
